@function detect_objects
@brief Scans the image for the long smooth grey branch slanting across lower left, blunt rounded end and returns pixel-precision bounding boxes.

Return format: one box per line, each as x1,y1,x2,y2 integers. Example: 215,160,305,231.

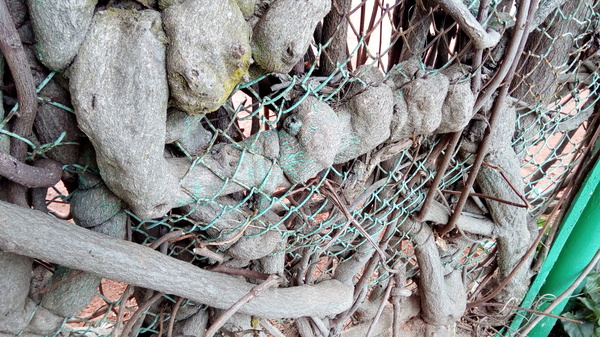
0,202,353,318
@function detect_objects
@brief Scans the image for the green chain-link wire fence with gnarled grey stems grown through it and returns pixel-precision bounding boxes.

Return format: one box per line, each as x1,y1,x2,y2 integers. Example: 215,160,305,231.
2,0,598,336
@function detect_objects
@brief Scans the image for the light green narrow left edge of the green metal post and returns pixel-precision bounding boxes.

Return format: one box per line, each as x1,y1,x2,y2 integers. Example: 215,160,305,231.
510,154,600,336
